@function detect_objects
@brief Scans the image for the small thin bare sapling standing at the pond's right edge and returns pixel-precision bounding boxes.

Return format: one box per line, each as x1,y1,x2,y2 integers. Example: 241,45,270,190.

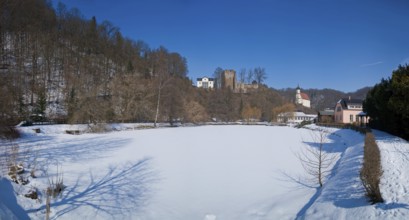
297,129,336,187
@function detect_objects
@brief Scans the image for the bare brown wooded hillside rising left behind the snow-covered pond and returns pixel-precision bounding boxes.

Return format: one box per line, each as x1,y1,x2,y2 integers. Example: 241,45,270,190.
0,0,284,124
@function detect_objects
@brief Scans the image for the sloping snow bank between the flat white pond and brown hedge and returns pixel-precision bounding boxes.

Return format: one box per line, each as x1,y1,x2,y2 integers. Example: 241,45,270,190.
297,130,374,219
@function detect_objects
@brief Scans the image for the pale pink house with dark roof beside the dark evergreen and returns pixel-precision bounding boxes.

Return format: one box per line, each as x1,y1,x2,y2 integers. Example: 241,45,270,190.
334,97,368,125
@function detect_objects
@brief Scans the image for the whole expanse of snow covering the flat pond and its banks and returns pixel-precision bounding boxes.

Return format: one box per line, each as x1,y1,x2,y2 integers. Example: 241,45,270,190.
0,125,409,220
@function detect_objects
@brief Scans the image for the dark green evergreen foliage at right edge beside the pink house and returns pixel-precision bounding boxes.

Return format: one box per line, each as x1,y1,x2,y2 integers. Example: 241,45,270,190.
363,64,409,140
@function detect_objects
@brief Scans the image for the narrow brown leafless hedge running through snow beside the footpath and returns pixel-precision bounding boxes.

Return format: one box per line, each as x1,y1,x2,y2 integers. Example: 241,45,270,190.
361,132,383,204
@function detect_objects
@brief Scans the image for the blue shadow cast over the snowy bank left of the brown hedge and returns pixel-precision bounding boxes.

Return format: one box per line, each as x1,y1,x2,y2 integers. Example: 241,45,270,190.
296,129,369,219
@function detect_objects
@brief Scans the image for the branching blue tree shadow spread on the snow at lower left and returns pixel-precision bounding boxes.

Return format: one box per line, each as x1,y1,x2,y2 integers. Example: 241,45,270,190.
28,158,158,219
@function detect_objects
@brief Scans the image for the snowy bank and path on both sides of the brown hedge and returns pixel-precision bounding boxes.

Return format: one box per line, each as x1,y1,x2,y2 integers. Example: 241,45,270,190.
299,131,409,219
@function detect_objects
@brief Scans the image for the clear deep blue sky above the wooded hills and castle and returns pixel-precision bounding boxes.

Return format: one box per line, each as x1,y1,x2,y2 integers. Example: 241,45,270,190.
53,0,409,92
